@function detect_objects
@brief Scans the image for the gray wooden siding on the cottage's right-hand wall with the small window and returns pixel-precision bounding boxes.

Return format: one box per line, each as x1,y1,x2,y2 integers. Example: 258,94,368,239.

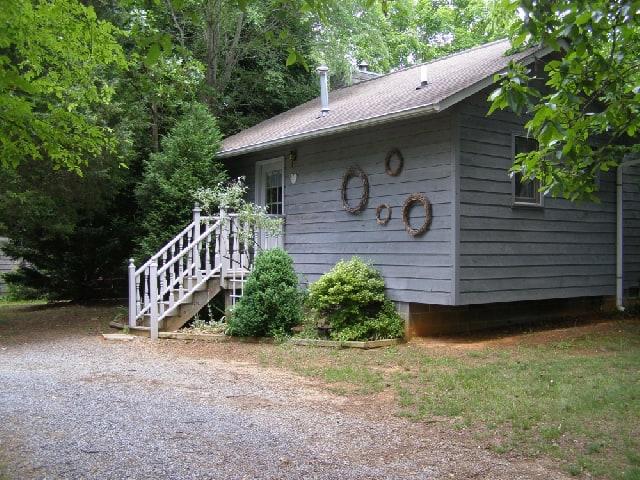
457,92,620,305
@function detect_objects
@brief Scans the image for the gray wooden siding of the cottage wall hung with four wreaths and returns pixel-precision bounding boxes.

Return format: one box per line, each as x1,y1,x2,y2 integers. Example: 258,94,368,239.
229,114,453,305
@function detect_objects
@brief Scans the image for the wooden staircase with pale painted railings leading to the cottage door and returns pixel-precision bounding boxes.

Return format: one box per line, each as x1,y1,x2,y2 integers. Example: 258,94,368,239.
127,205,281,339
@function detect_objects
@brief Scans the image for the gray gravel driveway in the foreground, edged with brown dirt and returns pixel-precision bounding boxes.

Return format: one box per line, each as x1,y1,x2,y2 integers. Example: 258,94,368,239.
0,326,570,480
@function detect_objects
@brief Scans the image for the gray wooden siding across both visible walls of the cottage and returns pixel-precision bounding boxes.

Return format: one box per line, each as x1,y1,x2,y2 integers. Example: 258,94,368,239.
222,91,640,305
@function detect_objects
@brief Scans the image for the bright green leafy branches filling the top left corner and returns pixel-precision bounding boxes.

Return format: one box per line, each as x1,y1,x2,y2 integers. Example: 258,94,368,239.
0,0,126,172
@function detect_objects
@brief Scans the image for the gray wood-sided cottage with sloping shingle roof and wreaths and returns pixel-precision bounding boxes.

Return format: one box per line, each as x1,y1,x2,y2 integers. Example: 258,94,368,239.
219,40,640,335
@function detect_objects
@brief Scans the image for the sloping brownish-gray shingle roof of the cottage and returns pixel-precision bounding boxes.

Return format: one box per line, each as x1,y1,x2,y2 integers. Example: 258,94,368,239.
218,40,546,158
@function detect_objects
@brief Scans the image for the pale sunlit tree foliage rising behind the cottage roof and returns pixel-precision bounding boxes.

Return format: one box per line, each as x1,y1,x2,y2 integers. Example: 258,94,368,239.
310,0,506,85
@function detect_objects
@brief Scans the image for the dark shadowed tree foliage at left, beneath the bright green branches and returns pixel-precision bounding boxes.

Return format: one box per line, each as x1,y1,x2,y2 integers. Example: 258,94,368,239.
0,150,132,299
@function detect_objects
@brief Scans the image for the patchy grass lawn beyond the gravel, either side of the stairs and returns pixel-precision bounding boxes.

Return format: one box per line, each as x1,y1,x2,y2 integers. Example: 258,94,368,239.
0,304,640,480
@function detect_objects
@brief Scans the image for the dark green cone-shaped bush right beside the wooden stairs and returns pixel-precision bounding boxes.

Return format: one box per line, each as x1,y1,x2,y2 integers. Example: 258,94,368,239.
227,248,302,337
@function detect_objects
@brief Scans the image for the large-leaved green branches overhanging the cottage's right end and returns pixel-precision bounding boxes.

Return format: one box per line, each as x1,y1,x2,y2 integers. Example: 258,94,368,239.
491,0,640,200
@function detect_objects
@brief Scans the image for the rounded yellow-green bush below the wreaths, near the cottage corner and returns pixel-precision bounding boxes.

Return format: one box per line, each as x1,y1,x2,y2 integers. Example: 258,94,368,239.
308,257,404,341
